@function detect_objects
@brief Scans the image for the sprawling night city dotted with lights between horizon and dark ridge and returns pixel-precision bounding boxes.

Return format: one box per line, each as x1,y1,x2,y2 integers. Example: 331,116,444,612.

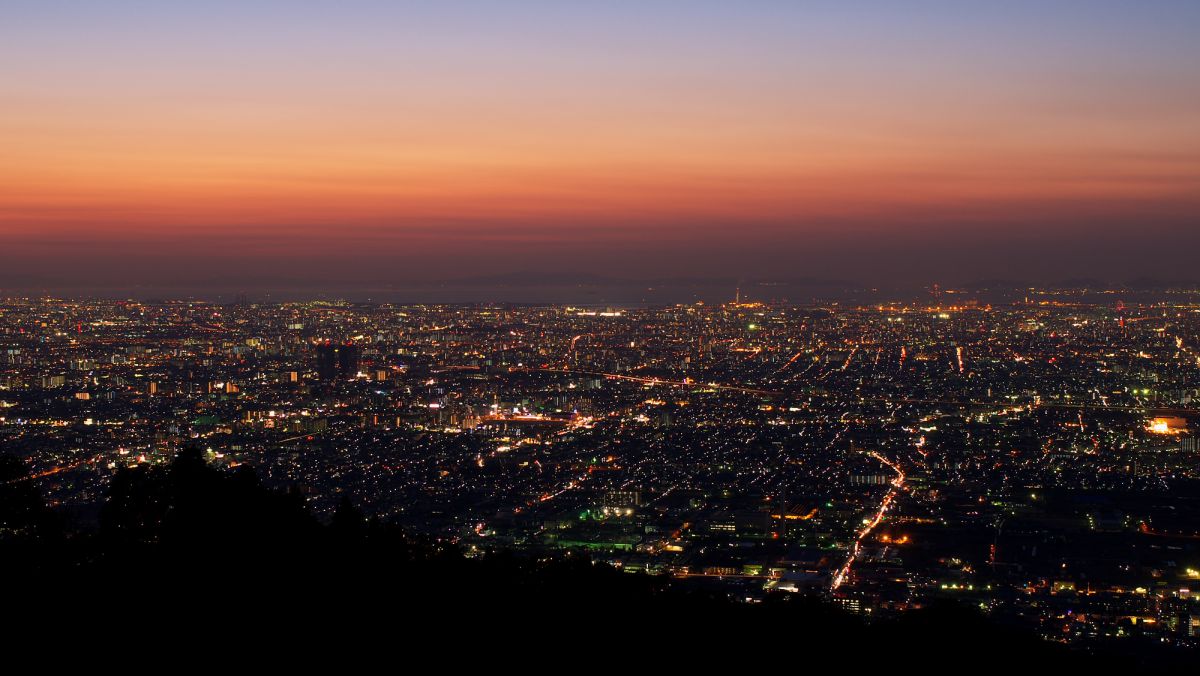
7,288,1200,647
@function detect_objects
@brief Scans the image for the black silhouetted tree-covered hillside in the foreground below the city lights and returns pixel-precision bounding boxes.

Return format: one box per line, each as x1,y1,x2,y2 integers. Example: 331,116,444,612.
0,450,1180,670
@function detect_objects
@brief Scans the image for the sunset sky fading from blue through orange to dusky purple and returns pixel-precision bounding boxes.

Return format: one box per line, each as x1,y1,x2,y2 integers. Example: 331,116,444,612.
0,0,1200,294
